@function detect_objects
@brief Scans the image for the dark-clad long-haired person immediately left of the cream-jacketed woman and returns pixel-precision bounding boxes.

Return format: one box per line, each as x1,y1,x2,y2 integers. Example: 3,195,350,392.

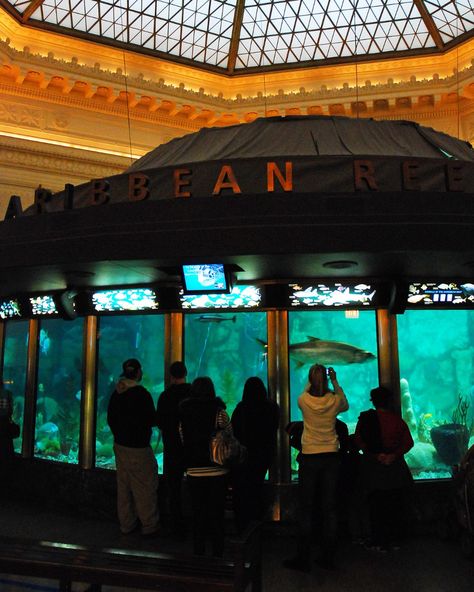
231,376,280,532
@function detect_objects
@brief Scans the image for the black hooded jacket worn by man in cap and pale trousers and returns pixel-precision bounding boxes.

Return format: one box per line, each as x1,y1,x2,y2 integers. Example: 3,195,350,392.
107,378,156,448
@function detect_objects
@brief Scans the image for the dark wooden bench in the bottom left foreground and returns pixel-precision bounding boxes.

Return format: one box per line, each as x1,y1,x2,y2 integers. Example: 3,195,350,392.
0,524,262,592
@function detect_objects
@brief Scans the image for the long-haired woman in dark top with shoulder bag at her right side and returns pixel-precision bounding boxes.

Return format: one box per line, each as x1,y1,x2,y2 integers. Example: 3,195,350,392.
179,376,232,557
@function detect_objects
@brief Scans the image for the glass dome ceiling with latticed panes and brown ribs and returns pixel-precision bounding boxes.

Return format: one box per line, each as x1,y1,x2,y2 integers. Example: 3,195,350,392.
0,0,474,74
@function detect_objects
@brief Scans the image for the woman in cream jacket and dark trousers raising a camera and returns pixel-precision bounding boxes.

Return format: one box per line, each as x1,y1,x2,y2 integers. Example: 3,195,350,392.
284,364,349,571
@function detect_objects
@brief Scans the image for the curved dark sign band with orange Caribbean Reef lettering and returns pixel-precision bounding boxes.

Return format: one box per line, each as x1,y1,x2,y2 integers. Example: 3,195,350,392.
5,156,474,220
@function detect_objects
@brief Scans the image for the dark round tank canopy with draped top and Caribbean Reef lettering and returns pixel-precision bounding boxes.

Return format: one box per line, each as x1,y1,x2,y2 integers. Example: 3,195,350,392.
0,116,474,293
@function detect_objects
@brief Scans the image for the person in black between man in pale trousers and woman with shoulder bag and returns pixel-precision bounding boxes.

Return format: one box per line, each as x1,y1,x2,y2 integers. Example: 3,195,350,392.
156,362,191,534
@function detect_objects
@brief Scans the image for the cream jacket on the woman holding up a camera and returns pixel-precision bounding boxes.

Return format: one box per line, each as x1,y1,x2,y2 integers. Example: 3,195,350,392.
298,386,349,454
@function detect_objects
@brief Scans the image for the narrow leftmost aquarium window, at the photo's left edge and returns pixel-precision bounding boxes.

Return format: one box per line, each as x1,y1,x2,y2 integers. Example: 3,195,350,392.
3,321,29,452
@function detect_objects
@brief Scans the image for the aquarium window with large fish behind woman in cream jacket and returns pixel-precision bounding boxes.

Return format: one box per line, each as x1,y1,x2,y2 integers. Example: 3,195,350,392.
289,310,378,478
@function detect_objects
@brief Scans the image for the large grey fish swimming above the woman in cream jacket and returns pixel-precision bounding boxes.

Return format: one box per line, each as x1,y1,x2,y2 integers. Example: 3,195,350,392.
258,335,375,368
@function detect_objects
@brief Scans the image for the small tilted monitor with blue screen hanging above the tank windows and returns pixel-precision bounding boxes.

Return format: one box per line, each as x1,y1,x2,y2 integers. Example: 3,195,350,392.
181,263,232,294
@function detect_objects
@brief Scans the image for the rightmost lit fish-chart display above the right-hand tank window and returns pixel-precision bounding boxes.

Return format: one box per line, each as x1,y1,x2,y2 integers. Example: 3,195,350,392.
407,282,474,307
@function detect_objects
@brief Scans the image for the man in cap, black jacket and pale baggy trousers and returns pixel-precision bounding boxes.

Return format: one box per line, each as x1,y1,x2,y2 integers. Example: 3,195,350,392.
107,358,158,536
